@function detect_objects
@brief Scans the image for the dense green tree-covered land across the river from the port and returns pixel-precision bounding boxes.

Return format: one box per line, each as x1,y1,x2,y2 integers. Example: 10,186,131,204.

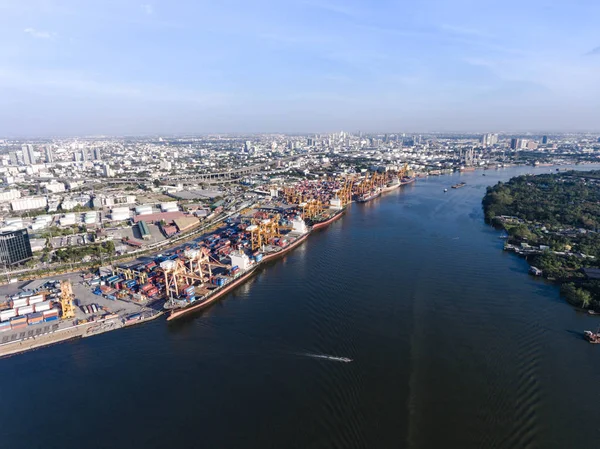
482,170,600,312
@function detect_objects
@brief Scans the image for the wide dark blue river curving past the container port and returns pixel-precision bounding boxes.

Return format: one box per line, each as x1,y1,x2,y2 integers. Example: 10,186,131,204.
0,167,600,449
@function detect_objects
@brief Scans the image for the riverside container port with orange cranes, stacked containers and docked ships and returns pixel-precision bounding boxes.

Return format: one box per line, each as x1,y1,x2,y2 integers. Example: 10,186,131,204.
0,173,414,356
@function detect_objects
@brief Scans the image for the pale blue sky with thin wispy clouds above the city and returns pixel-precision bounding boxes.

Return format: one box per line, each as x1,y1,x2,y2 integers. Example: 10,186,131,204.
0,0,600,136
